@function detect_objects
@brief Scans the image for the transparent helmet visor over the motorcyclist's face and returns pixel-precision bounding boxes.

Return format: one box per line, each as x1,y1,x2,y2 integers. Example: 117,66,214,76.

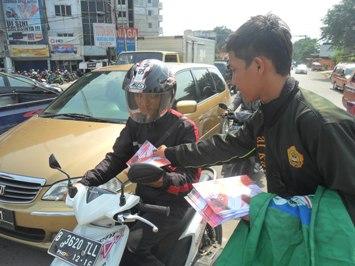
126,91,173,123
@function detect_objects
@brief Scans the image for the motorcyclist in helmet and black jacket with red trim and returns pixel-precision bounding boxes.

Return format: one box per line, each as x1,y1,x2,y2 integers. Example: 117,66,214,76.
80,60,200,265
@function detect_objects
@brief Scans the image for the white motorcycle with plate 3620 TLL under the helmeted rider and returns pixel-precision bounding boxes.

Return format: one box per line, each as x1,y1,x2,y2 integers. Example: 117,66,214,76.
48,155,222,266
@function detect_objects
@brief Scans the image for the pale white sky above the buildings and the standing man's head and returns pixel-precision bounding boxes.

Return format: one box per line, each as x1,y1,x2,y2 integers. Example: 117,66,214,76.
160,0,341,41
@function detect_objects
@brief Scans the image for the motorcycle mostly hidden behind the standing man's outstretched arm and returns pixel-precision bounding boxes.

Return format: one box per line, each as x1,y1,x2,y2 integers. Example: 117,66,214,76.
219,103,261,177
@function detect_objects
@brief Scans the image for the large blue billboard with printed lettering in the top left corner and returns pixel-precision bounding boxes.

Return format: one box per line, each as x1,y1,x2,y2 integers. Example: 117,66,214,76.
2,0,45,44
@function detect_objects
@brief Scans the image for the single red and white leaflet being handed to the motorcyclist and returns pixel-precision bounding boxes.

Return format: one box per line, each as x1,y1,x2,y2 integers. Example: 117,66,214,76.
127,140,170,167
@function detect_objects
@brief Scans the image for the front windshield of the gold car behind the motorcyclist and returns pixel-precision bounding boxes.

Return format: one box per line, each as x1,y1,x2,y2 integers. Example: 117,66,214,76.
41,71,128,123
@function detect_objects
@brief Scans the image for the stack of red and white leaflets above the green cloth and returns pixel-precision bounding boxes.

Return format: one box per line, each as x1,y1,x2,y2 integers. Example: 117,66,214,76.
185,175,262,227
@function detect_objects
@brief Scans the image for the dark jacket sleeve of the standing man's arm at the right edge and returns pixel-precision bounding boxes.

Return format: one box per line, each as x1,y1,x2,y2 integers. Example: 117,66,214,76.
302,116,355,221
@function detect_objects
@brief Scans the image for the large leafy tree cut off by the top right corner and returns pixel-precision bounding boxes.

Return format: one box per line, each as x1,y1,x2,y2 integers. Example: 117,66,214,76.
321,0,355,54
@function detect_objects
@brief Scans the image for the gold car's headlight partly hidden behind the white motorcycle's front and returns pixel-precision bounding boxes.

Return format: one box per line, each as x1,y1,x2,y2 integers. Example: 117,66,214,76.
42,178,121,201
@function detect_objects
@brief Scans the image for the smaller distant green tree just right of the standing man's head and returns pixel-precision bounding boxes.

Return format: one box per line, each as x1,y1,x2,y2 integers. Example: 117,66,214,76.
293,37,319,63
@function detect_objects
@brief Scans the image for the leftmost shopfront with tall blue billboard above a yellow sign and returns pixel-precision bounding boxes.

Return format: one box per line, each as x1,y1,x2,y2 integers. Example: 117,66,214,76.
1,0,50,71
